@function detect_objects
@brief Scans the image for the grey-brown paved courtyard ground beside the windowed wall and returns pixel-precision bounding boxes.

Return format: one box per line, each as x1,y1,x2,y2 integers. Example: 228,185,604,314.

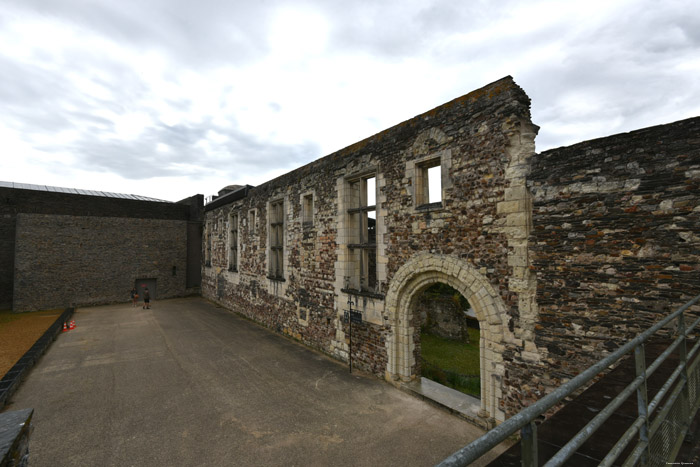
5,298,504,467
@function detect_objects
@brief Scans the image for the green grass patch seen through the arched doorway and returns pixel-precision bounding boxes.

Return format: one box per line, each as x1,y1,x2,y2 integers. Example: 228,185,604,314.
421,328,481,397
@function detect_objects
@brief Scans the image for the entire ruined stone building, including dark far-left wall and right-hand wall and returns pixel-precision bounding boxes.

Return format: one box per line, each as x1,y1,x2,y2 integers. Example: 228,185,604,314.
0,77,700,422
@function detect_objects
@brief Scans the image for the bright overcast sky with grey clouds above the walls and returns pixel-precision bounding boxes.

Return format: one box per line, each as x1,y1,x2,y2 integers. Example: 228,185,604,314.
0,0,700,201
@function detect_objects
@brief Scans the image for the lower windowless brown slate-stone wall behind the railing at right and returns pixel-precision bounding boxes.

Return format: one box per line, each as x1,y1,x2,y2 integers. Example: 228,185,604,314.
505,118,700,416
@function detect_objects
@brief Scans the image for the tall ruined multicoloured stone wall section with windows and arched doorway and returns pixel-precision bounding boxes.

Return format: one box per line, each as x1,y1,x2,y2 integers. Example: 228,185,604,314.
202,77,537,419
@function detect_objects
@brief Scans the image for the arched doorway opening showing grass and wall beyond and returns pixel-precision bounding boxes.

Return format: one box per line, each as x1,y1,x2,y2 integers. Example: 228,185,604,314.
415,283,481,397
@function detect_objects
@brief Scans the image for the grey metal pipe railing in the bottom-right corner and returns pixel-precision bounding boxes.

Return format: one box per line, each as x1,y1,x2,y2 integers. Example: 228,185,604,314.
438,295,700,467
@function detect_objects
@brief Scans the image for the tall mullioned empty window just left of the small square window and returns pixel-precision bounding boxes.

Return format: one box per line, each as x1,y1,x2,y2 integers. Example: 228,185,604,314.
347,176,377,292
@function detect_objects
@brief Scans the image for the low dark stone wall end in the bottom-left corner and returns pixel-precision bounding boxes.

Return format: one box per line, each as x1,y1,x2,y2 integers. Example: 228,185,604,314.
0,409,34,467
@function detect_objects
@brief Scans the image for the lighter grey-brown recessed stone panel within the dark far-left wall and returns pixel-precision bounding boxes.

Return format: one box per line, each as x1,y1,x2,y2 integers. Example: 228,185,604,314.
14,214,187,311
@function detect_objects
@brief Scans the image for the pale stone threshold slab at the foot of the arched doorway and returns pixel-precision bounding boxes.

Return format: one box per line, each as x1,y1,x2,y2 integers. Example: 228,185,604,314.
399,377,493,430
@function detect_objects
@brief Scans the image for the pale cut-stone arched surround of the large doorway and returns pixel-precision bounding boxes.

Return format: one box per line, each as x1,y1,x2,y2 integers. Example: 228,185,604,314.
386,253,506,422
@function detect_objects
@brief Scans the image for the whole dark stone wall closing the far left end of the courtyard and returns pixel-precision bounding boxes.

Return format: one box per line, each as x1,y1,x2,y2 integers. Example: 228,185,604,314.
0,187,203,311
